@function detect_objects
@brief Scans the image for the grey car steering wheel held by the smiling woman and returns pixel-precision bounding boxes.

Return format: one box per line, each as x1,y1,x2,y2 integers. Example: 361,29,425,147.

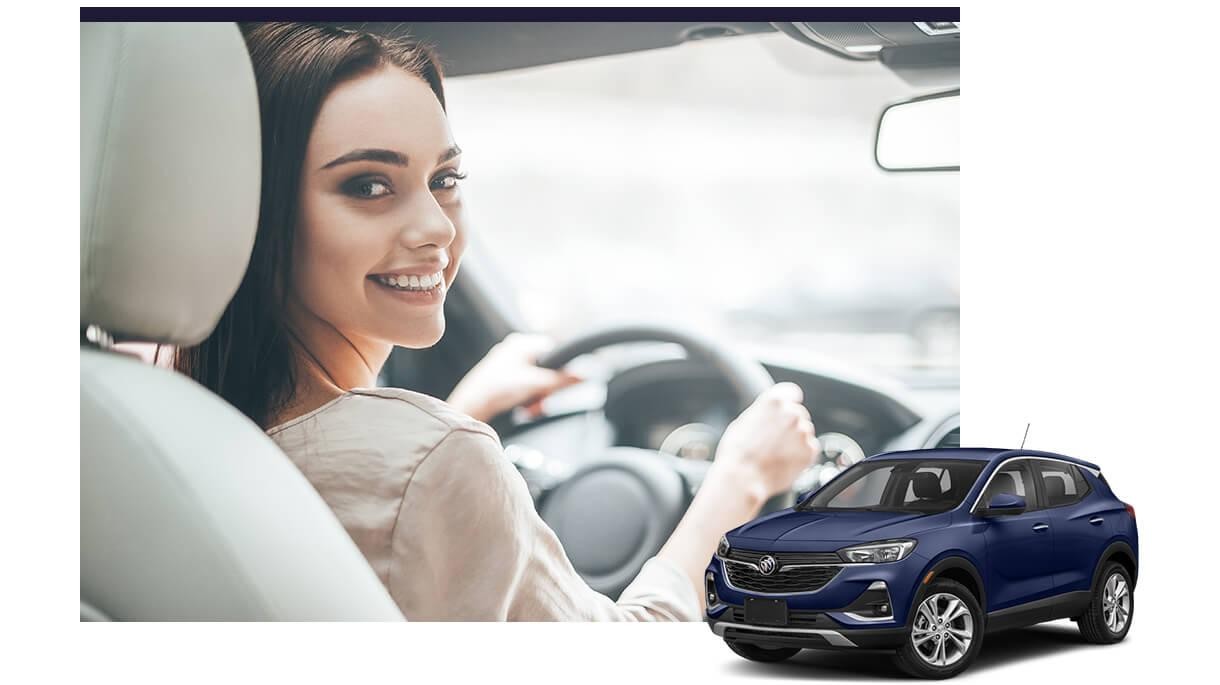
538,326,794,597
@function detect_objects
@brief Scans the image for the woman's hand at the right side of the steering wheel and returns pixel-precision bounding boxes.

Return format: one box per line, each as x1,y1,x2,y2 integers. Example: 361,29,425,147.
708,382,821,506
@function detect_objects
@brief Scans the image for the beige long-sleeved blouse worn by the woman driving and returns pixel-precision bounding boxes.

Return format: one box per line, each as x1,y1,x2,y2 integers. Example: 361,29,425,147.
267,388,702,620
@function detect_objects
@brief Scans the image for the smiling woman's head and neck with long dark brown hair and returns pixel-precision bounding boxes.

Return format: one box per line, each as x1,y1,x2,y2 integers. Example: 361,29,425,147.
174,24,465,427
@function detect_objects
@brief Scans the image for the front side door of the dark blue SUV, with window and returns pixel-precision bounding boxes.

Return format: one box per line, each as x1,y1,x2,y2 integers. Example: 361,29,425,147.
978,459,1054,612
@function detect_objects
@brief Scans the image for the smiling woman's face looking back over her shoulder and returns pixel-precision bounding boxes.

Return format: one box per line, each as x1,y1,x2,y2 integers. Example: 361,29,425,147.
292,66,466,349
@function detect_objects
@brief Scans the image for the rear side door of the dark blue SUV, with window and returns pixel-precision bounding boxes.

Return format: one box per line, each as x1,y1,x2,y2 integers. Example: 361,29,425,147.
1031,459,1113,595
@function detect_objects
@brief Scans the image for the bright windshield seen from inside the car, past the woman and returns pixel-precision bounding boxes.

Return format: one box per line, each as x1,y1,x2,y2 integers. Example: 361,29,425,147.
445,33,959,383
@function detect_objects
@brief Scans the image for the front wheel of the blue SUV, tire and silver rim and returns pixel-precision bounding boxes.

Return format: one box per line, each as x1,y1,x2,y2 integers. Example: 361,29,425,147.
894,578,986,679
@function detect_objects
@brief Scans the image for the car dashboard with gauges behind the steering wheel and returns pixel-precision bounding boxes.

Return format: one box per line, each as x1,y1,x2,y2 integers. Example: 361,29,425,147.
497,346,960,499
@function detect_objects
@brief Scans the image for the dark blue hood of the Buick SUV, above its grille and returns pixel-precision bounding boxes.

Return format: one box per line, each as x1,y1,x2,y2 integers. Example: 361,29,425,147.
730,509,949,546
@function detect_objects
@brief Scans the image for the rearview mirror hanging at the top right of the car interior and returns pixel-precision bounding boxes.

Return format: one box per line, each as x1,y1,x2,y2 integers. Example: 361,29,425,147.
874,90,961,171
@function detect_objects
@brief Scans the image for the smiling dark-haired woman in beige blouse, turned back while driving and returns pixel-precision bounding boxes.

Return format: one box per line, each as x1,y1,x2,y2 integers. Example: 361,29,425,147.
167,24,819,620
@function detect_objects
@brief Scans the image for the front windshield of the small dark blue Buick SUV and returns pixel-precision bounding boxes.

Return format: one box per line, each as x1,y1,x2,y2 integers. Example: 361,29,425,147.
798,459,983,514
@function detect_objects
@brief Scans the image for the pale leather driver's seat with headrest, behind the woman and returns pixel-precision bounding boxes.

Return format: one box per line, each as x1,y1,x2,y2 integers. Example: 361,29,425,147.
81,23,403,620
